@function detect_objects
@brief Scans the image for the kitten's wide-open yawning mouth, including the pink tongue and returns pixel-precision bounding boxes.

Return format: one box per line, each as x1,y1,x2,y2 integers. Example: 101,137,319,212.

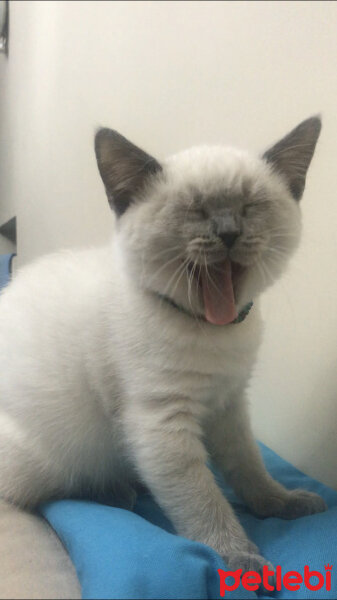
186,258,245,325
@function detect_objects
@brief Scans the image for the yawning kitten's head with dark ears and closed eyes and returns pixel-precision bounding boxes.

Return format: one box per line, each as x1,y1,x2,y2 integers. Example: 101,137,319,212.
95,117,321,325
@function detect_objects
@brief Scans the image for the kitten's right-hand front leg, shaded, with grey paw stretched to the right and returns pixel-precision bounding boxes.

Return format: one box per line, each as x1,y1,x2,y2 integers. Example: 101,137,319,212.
206,395,327,519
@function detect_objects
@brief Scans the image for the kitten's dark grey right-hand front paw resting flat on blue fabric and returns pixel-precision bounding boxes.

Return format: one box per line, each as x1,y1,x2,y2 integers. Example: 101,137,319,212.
254,489,327,519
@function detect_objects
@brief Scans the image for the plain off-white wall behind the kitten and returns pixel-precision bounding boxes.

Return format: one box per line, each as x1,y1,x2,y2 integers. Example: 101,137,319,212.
0,1,337,487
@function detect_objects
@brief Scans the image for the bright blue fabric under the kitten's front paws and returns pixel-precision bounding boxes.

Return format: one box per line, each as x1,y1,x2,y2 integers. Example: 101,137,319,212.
41,445,337,599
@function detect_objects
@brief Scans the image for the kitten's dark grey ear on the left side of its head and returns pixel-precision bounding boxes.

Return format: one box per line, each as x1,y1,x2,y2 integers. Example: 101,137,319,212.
95,129,162,216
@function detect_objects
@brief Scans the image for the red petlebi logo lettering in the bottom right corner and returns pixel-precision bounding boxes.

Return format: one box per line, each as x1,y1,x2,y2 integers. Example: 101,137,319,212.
218,564,332,597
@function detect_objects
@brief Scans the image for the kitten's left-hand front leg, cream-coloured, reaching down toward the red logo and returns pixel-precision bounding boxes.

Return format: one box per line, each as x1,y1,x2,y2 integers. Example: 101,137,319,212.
125,397,268,571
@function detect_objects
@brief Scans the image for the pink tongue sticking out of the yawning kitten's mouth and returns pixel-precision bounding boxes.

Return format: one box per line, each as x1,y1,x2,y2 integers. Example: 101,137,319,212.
201,258,238,325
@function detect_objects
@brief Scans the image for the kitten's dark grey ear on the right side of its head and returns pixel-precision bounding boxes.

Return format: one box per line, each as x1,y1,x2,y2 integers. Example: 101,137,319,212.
263,116,322,200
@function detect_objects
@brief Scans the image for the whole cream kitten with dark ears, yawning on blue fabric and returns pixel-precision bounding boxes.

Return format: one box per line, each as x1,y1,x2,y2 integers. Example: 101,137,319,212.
0,116,326,571
